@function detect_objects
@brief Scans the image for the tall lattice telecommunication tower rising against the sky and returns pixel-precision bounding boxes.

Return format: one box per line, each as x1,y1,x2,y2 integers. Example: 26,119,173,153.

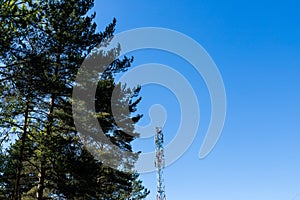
155,127,166,200
